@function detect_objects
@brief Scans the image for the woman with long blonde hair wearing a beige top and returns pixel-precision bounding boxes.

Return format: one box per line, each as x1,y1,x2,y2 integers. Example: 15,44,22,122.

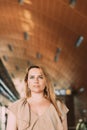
7,66,68,130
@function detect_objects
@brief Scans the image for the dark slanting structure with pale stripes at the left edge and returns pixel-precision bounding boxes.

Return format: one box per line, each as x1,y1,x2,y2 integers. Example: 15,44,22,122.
0,59,19,101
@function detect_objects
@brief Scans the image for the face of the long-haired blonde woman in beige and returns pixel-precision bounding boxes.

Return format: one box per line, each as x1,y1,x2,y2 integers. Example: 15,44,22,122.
28,68,46,93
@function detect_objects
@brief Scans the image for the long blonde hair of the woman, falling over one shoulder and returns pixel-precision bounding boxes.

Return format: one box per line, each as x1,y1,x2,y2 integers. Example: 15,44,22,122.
24,65,61,119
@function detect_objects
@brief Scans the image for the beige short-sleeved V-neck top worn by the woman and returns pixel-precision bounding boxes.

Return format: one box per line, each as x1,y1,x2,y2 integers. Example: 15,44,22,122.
9,98,68,130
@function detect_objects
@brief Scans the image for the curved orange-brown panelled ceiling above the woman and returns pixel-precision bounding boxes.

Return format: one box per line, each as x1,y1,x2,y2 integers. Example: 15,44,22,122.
0,0,87,96
